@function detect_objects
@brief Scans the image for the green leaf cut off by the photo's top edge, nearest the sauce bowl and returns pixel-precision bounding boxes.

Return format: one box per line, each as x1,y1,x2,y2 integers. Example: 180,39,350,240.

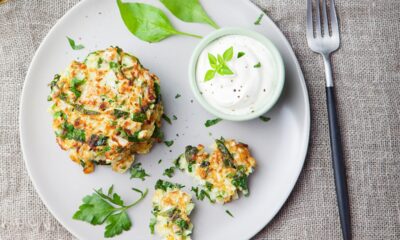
160,0,219,29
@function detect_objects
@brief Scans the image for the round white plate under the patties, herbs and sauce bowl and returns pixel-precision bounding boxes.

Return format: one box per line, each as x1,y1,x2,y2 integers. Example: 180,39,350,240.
20,0,310,240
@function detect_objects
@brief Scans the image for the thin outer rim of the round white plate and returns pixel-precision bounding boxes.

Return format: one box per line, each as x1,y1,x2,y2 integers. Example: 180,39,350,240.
18,0,311,239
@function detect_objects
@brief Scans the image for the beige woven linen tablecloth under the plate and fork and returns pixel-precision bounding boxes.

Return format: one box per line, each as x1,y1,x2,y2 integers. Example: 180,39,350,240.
0,0,400,240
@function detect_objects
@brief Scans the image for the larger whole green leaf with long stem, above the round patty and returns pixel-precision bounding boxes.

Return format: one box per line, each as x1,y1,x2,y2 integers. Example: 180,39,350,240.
117,0,201,43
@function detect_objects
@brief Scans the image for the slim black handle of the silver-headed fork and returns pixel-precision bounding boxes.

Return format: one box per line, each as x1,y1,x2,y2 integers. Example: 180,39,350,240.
326,86,351,240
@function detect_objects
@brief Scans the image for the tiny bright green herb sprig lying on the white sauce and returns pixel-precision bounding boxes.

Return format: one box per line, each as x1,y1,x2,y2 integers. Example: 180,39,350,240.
204,47,233,82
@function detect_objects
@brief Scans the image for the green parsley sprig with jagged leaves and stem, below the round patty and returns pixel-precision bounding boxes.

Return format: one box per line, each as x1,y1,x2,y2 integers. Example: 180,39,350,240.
72,186,148,238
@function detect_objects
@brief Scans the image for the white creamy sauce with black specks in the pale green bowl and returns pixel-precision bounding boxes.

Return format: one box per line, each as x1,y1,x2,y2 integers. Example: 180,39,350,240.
196,35,276,115
